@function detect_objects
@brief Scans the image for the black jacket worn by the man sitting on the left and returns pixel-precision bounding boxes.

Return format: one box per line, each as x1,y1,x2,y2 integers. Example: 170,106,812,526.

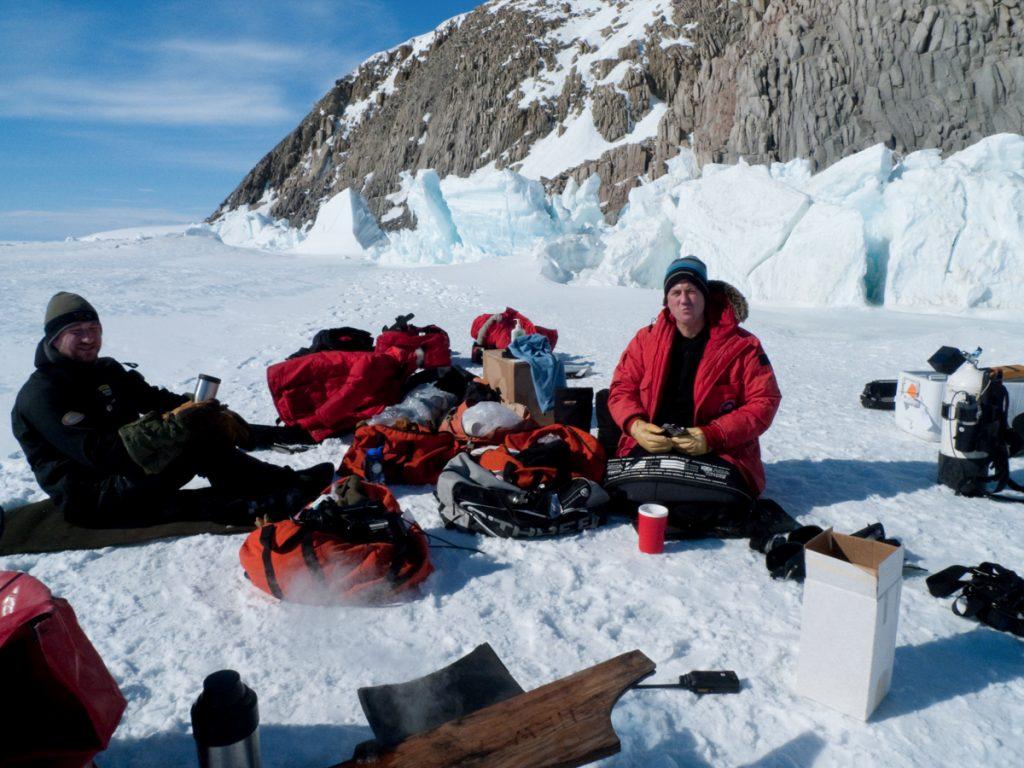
11,341,187,515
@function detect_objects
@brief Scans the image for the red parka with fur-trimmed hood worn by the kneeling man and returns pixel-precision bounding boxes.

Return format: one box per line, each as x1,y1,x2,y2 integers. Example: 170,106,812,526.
608,281,782,494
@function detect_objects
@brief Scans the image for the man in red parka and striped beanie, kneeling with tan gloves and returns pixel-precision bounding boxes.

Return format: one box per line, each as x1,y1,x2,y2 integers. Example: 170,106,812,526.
608,256,781,497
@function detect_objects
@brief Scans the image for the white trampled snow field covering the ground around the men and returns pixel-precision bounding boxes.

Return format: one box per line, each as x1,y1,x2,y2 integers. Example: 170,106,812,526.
0,237,1024,768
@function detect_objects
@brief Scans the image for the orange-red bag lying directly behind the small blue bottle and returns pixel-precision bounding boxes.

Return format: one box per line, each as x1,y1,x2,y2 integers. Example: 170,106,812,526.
341,424,459,485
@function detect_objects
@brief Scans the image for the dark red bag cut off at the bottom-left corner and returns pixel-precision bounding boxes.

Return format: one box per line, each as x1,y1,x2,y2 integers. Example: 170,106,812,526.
0,570,125,768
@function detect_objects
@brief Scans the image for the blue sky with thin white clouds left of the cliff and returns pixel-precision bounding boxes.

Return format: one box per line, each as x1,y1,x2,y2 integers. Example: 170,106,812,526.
0,0,479,240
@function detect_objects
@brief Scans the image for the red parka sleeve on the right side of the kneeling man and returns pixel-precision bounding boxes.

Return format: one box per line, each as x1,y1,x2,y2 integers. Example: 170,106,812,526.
700,344,782,451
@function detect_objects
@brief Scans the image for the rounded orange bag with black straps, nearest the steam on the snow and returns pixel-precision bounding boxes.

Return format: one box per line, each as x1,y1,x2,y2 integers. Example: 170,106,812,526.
239,478,433,605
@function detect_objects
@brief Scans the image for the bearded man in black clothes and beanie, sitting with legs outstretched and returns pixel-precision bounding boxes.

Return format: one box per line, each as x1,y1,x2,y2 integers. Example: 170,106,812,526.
11,292,332,526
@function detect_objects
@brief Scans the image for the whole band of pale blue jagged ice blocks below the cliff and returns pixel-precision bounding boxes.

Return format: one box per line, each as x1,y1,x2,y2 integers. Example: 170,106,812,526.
211,134,1024,310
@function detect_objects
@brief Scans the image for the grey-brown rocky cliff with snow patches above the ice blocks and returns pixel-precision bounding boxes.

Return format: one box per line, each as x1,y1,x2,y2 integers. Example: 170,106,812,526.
212,0,1024,228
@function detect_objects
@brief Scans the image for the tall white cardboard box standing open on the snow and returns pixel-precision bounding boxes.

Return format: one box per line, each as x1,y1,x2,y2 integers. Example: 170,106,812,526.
797,528,903,720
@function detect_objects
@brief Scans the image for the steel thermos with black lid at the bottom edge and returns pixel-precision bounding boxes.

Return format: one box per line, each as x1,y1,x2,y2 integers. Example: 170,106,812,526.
191,670,260,768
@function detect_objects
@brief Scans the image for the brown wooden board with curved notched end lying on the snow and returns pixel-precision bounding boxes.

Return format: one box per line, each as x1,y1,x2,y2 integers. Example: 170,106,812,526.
334,650,654,768
